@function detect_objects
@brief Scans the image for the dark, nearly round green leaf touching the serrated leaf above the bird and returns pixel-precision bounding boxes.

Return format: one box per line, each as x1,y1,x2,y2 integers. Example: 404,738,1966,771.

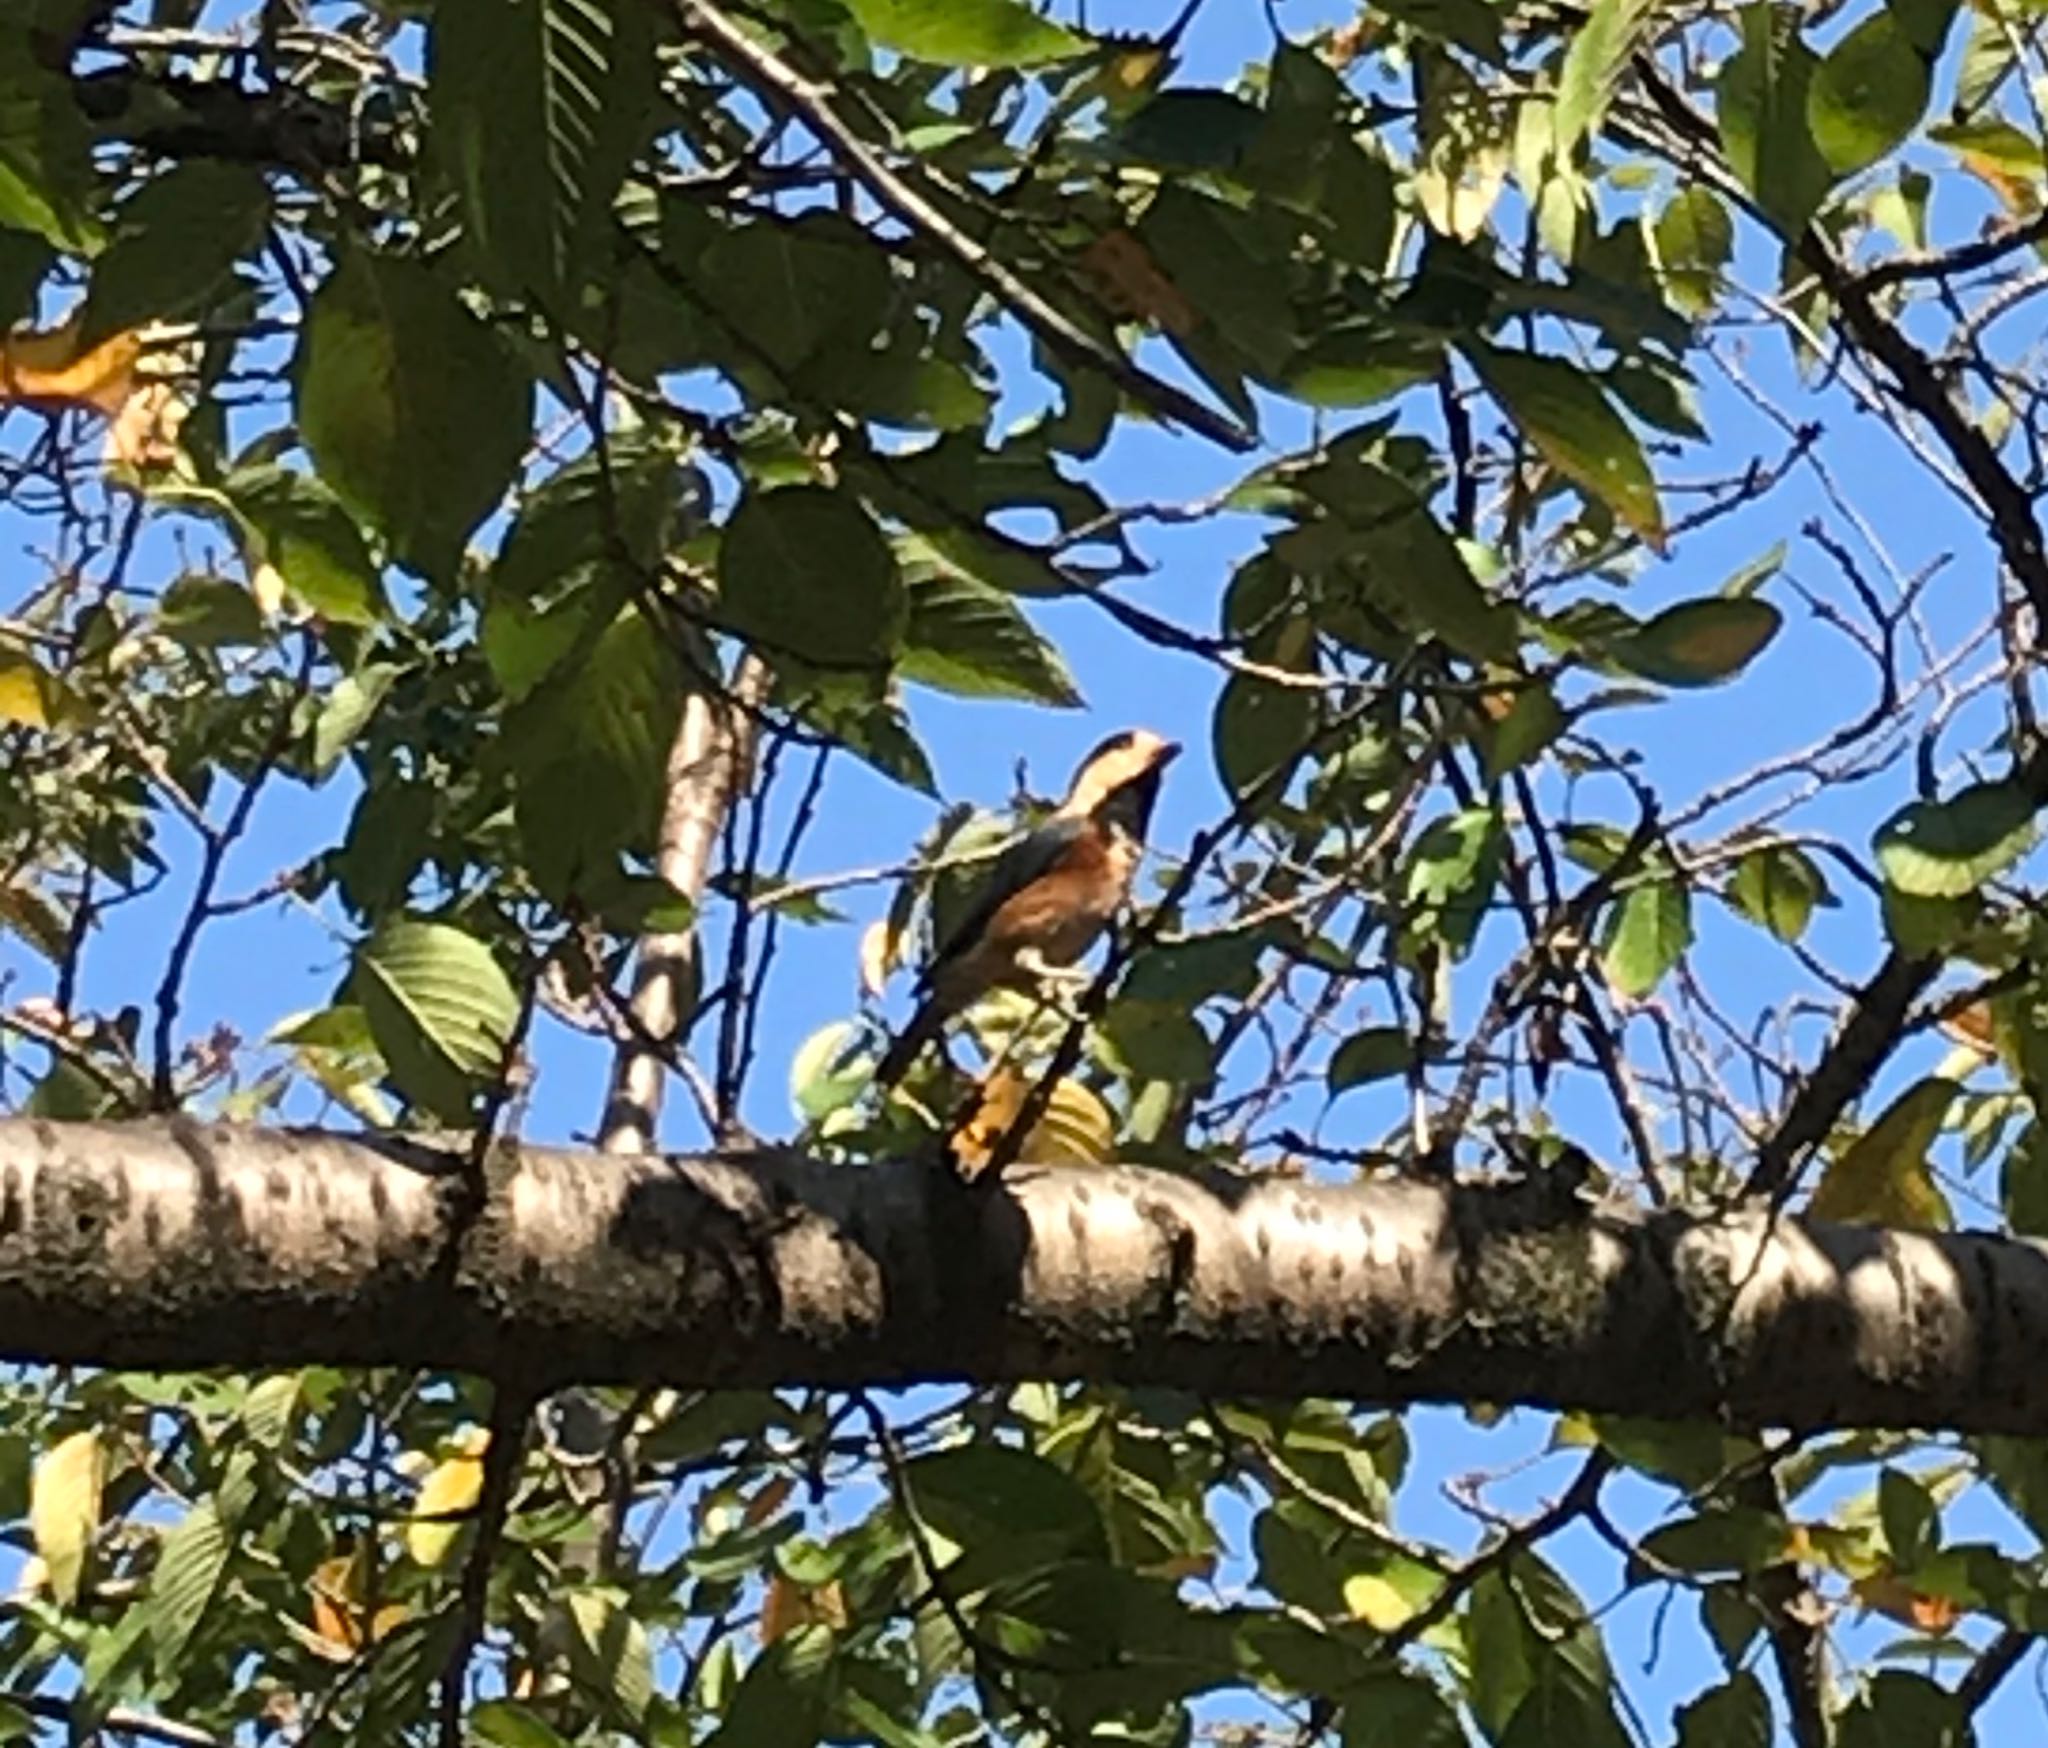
719,485,909,667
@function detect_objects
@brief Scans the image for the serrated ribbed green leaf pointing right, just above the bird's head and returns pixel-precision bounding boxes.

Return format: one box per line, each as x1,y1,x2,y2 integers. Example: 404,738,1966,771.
897,536,1081,710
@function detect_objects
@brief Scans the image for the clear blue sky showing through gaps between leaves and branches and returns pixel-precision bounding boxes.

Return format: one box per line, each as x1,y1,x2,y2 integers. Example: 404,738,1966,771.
0,0,2048,1744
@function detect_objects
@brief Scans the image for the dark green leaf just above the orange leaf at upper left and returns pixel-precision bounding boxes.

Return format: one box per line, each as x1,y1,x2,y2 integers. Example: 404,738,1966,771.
80,160,270,346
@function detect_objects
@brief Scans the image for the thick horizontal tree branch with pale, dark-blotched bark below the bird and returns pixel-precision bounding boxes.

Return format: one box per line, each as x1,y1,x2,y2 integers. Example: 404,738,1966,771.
0,1118,2048,1433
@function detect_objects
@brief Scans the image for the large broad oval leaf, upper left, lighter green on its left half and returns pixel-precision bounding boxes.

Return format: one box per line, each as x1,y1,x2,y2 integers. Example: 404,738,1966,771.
295,250,532,577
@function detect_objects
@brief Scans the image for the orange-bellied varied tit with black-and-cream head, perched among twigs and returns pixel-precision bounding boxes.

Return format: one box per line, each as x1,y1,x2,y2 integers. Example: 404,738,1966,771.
874,729,1180,1087
